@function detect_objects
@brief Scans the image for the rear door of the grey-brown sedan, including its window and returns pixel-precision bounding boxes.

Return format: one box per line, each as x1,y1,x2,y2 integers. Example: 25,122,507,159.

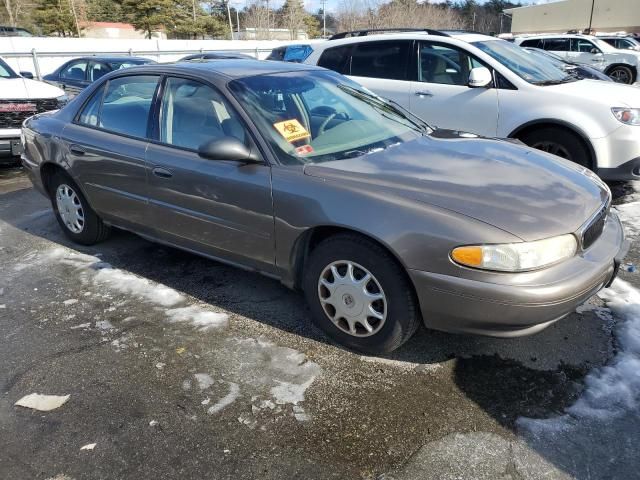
63,75,159,227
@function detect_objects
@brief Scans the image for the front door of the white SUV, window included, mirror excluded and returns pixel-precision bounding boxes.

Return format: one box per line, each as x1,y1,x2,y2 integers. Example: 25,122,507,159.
410,41,498,137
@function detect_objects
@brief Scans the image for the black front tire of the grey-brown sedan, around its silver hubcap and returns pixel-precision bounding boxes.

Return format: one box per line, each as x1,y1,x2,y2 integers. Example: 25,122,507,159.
303,234,421,354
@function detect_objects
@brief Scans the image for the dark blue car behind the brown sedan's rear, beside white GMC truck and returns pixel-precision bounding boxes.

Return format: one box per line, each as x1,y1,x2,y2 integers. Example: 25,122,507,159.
44,56,155,98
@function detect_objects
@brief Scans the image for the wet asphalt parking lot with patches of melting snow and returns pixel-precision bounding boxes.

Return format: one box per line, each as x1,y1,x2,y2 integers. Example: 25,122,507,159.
0,165,640,480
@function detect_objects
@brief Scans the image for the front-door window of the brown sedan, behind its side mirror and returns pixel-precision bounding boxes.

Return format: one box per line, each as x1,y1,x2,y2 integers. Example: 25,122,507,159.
160,78,248,150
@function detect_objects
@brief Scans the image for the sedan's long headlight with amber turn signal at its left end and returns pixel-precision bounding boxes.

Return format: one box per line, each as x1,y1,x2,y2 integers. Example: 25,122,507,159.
451,234,578,272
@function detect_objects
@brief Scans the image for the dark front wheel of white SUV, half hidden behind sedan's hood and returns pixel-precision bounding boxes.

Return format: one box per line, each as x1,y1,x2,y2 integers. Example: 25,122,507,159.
519,127,592,168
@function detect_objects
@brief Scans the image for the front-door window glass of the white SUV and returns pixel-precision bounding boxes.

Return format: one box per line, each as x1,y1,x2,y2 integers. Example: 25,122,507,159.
418,42,483,86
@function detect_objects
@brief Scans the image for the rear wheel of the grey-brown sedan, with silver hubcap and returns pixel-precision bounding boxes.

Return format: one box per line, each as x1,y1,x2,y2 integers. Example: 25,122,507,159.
49,172,109,245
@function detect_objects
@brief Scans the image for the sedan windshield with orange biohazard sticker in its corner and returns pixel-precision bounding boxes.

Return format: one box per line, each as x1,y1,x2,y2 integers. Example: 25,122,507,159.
229,71,431,164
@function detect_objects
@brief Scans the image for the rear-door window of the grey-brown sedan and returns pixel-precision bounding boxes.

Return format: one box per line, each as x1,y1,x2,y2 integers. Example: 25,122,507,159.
79,75,159,138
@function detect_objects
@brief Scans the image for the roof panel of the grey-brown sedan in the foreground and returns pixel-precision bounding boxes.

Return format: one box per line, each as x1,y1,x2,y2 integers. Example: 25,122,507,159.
114,58,324,79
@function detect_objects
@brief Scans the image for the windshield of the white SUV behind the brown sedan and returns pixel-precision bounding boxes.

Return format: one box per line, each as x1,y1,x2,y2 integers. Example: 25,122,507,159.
473,40,576,85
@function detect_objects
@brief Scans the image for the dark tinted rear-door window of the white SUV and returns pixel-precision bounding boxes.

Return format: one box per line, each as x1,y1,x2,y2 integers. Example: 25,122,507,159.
350,41,412,80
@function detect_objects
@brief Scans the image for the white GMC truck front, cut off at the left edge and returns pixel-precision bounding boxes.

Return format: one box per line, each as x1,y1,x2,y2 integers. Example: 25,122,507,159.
0,58,67,164
